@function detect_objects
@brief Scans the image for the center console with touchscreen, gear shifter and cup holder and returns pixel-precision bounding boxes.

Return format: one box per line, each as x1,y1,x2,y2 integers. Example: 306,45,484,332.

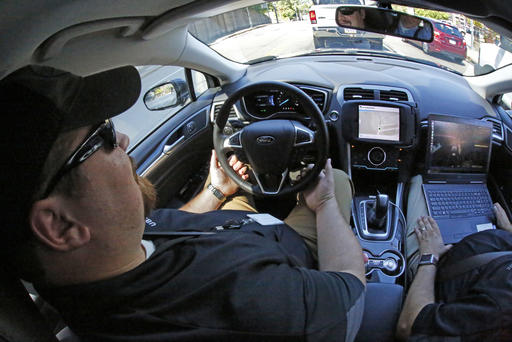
342,100,418,285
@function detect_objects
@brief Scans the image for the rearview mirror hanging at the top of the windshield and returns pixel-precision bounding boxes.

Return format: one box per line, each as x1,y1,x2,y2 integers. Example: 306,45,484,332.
336,5,433,42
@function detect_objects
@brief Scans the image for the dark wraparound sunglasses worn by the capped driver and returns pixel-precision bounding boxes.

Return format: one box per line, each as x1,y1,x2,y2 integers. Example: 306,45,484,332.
41,120,118,198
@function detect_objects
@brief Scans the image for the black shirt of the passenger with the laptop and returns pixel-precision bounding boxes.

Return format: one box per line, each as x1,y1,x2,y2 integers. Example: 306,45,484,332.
409,230,512,342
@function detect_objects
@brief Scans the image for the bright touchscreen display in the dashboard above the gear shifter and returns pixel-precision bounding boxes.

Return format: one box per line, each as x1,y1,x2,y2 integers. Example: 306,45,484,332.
358,105,400,141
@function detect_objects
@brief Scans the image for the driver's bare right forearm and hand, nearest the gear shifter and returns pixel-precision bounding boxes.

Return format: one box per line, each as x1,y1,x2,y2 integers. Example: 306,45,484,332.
304,159,366,284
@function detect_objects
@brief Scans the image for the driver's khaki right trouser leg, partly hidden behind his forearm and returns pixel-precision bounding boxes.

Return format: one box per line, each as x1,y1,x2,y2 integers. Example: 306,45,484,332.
284,169,354,260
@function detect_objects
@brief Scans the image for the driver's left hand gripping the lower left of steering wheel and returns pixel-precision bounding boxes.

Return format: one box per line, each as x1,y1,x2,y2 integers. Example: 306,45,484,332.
210,150,249,196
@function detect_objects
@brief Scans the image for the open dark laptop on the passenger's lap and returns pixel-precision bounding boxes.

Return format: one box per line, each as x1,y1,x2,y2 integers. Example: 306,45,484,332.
423,115,495,244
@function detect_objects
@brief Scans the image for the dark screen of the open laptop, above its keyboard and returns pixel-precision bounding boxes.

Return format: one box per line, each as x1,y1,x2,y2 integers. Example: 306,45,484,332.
426,115,492,173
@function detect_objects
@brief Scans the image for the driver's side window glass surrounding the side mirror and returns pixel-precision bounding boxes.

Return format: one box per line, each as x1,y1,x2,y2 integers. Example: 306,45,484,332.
113,65,208,149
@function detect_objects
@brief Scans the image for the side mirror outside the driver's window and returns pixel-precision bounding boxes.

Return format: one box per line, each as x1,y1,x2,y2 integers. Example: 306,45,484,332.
144,78,189,110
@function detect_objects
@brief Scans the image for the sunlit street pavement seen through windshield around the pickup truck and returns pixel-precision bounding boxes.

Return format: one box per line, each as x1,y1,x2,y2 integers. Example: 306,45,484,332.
210,21,473,75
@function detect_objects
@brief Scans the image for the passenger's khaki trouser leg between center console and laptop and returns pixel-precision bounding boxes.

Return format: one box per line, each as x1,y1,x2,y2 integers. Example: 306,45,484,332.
406,175,428,280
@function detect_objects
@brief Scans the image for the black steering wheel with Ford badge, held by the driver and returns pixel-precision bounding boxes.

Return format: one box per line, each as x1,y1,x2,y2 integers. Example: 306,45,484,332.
213,81,329,197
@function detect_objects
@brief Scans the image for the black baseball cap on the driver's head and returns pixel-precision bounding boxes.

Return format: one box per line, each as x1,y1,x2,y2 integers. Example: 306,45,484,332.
0,66,141,254
